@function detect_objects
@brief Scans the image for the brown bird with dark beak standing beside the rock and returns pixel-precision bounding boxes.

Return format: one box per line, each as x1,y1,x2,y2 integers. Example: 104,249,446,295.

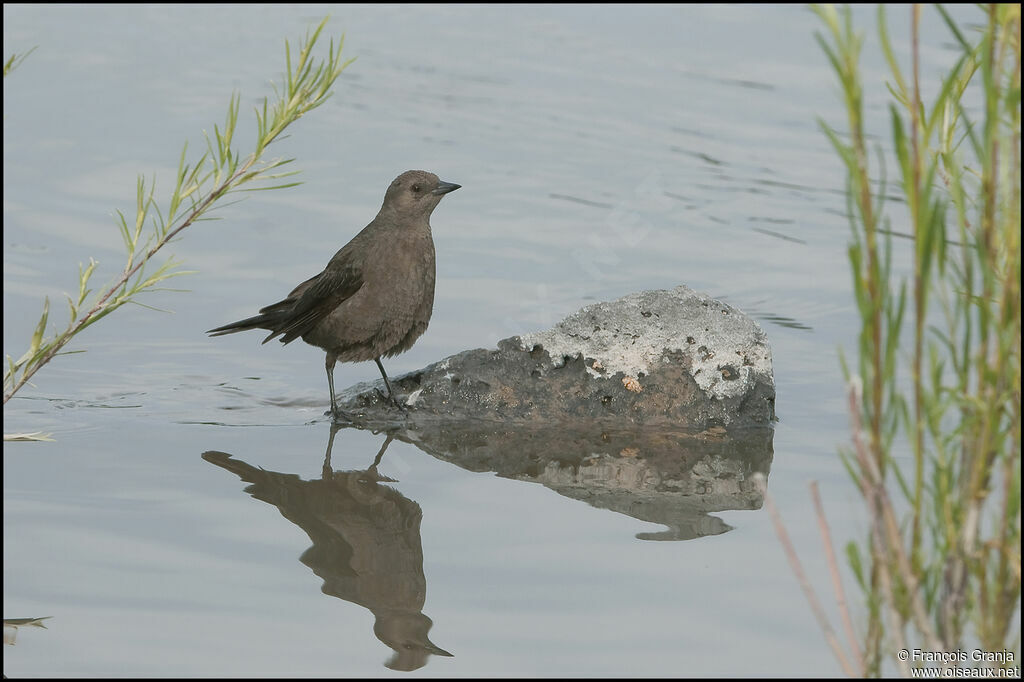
207,170,462,419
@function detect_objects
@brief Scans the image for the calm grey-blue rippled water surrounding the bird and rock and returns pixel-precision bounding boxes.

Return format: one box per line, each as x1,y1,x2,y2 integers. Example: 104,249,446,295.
4,5,971,676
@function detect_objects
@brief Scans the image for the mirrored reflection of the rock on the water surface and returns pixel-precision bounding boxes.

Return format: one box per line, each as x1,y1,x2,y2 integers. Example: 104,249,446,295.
392,422,774,540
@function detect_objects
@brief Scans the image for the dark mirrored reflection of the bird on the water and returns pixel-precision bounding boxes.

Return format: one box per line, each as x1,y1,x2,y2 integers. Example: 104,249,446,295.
203,425,452,671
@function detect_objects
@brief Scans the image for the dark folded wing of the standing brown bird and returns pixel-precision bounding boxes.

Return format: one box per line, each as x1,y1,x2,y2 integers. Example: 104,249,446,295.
260,261,362,343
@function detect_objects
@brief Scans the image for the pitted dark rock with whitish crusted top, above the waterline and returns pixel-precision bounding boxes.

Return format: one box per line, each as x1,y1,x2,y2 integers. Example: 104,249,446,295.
339,286,775,430
